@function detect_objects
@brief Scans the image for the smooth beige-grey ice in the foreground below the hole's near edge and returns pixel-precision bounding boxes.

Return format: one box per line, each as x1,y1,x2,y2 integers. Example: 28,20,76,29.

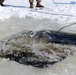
0,55,76,75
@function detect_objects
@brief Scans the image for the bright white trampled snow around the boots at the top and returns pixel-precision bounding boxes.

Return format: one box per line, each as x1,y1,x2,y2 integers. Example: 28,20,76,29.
0,0,76,23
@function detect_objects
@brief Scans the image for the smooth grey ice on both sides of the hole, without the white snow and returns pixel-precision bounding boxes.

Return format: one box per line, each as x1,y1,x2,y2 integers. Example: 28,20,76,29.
0,18,76,75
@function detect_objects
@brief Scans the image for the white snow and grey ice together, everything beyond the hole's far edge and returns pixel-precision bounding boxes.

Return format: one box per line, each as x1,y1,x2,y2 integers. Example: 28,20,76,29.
0,0,76,40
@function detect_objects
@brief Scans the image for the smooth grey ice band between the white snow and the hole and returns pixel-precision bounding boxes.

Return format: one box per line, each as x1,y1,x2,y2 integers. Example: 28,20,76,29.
0,17,76,40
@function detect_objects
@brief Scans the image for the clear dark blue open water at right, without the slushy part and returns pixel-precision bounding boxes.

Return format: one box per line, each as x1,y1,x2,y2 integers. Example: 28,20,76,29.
50,32,76,45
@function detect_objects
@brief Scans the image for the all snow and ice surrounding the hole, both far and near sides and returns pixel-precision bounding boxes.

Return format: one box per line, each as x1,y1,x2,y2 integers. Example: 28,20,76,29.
0,0,76,75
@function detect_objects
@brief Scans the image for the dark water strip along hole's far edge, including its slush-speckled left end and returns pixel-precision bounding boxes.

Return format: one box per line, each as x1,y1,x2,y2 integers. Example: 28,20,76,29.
33,31,76,45
